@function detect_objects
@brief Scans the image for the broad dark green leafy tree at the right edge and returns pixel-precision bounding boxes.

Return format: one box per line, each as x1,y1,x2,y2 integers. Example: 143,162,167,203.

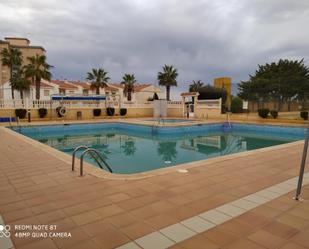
238,59,309,111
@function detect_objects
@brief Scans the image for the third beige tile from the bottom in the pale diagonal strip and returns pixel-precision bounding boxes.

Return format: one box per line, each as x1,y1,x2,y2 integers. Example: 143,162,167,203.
160,223,197,243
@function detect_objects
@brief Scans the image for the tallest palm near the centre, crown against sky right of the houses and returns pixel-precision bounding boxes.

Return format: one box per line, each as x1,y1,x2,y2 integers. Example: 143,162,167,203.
158,65,178,100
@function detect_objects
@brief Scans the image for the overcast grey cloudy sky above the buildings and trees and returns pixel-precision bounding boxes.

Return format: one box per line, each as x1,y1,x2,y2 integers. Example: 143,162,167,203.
0,0,309,96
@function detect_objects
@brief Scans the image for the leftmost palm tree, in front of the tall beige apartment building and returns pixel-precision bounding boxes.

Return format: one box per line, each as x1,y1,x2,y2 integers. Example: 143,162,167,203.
1,48,23,99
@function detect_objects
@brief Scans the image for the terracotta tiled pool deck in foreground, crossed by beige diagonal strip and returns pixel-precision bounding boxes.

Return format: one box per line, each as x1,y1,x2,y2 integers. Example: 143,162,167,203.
0,123,309,249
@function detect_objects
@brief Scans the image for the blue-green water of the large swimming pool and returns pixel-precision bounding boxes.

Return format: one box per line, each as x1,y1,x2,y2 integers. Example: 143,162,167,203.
12,123,305,174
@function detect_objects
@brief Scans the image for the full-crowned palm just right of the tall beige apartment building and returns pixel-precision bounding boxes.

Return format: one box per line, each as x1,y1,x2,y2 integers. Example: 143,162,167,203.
25,54,52,99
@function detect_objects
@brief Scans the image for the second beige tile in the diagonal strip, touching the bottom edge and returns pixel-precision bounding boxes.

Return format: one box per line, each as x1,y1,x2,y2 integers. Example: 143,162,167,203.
135,232,175,249
